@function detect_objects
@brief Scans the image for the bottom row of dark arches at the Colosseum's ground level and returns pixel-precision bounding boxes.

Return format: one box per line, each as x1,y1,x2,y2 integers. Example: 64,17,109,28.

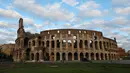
31,52,117,61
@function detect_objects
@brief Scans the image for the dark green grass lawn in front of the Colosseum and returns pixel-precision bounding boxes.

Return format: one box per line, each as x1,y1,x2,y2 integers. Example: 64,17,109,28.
0,63,130,73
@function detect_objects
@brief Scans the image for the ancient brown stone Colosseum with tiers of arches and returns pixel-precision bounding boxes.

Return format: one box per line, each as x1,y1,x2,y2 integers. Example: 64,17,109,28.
13,18,119,62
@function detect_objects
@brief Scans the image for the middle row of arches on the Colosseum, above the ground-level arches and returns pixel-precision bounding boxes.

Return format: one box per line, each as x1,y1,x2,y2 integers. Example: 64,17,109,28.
29,39,117,49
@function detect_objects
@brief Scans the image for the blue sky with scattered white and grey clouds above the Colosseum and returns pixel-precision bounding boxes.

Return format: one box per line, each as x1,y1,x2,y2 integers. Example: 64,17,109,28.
0,0,130,51
